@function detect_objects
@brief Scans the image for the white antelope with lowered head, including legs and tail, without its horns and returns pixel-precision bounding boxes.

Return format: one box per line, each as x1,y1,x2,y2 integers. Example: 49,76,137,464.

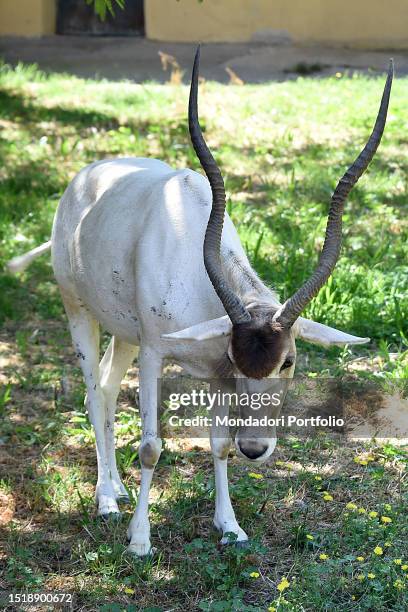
9,50,391,556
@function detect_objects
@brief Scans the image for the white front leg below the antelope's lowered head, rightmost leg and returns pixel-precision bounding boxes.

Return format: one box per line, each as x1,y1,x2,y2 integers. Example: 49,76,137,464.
210,381,248,544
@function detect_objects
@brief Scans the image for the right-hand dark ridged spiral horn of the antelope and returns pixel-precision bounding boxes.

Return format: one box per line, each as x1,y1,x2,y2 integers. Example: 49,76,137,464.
274,60,394,328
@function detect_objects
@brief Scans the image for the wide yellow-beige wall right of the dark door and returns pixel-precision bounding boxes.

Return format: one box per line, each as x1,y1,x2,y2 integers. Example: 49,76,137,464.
145,0,408,48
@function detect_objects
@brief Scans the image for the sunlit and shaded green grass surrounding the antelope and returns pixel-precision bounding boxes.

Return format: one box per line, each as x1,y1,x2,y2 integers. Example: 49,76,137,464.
0,66,408,612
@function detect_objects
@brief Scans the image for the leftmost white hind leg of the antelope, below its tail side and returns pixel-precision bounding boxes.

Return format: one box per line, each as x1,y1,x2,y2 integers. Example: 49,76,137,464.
63,295,119,516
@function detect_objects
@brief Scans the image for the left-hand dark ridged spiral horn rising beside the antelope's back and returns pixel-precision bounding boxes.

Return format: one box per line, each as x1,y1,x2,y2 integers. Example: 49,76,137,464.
188,47,251,325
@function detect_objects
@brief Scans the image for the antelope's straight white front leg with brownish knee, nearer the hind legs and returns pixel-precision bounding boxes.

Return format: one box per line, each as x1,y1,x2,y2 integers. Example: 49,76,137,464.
128,347,162,557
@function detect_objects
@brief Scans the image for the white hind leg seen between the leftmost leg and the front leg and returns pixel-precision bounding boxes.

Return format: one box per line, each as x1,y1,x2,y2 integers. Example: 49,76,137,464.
99,336,138,501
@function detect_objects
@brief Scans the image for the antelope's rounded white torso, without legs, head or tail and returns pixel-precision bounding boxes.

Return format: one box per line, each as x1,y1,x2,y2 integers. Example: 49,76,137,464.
52,158,244,337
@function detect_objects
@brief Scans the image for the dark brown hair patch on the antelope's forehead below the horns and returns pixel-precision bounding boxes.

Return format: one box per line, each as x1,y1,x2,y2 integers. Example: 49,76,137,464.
231,311,290,379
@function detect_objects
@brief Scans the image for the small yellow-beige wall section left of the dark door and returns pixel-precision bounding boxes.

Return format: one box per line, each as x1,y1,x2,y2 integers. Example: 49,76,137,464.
0,0,56,36
